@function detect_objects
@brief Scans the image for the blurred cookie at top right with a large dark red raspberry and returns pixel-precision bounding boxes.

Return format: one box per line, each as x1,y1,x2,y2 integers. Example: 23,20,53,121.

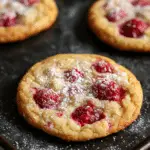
88,0,150,52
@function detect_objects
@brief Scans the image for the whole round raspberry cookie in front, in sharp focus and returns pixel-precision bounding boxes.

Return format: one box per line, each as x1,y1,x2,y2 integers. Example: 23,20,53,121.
17,54,143,141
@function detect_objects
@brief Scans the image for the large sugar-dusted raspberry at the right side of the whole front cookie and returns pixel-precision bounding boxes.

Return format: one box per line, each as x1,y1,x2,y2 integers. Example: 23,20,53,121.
92,79,125,102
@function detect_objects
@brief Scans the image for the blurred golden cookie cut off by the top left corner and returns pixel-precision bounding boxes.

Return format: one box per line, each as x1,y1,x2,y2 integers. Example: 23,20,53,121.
0,0,58,43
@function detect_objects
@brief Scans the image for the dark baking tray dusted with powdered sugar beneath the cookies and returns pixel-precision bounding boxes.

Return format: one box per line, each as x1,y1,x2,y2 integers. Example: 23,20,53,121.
0,0,150,150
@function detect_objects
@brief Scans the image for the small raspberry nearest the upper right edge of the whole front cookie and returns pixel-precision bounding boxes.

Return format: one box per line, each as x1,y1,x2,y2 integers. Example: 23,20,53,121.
93,60,114,73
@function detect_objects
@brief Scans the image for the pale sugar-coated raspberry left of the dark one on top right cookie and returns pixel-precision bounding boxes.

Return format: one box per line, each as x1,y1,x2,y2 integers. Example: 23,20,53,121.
106,9,127,22
